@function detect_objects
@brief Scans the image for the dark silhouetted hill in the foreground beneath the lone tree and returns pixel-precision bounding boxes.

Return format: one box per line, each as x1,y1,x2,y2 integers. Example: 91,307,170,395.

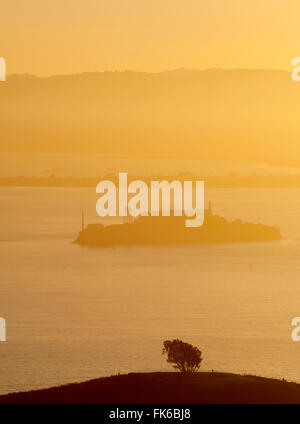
0,372,300,404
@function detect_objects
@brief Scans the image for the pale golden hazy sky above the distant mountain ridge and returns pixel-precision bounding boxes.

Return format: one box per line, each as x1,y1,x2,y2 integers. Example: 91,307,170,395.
0,0,300,75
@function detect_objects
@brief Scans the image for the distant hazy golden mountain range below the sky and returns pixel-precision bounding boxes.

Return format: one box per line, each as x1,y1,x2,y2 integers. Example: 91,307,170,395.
0,69,300,166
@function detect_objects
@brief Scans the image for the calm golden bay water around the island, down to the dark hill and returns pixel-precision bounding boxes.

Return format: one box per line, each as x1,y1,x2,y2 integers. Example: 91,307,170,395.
0,188,300,393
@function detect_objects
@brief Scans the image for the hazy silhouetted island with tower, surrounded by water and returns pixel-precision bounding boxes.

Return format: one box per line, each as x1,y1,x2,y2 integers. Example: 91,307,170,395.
74,203,281,246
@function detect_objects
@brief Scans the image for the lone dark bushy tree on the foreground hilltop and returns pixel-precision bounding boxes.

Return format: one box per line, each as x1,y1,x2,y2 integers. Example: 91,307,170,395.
162,339,202,372
